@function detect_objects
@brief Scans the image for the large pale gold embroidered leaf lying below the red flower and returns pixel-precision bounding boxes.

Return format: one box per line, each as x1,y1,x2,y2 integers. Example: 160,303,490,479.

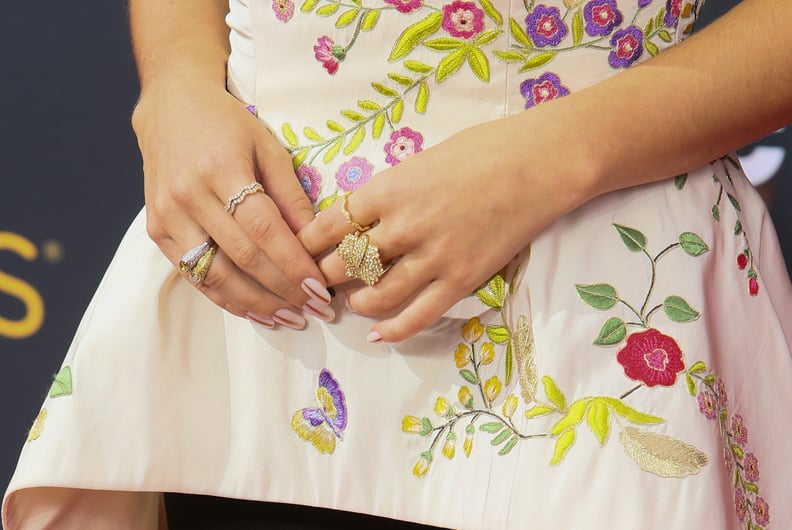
619,426,709,478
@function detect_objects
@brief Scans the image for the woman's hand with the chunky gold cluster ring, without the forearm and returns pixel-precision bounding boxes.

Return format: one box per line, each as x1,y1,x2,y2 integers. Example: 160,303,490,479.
298,111,582,342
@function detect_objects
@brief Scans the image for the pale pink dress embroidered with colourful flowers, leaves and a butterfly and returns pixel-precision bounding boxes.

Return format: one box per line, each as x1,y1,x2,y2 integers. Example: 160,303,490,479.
3,0,792,530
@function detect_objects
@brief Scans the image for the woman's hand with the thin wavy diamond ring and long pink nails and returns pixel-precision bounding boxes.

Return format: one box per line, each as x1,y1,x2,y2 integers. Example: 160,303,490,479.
132,82,334,329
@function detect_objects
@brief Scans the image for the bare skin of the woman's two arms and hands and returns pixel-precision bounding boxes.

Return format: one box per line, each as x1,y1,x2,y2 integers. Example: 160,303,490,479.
132,0,792,342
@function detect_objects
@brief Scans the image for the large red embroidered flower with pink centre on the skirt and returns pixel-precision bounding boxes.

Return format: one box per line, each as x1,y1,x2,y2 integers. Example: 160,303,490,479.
616,329,685,386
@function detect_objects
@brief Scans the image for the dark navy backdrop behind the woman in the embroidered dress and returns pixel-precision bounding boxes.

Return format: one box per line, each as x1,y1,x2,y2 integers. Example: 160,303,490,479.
0,0,792,504
